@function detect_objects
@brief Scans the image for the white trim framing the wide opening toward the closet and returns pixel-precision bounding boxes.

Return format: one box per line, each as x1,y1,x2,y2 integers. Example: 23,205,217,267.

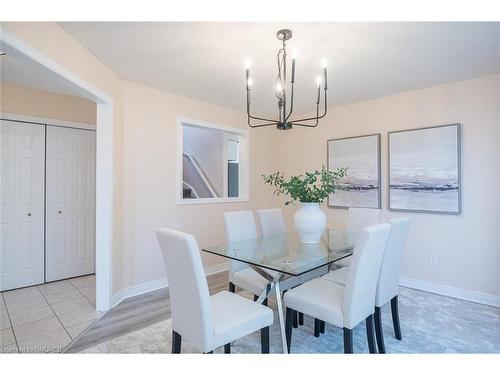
0,27,114,311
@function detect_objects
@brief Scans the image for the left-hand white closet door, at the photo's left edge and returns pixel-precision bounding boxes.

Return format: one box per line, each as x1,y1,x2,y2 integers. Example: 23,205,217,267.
0,120,45,291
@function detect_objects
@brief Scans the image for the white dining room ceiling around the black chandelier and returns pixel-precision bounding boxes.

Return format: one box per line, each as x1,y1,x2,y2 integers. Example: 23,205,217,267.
7,22,500,115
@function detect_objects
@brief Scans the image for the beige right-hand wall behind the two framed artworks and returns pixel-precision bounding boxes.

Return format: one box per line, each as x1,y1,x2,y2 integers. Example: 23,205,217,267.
275,75,500,296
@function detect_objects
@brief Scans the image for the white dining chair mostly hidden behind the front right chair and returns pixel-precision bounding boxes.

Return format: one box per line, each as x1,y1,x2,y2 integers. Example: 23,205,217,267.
323,217,412,353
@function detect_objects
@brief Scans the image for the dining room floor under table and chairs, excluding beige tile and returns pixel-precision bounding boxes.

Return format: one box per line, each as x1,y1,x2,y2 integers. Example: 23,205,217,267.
68,272,500,353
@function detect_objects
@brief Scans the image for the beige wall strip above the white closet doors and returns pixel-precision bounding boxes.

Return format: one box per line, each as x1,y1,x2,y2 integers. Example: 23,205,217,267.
0,84,96,125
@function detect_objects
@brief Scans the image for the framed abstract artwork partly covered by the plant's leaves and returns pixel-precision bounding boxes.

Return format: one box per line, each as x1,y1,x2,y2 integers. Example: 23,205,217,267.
327,134,381,208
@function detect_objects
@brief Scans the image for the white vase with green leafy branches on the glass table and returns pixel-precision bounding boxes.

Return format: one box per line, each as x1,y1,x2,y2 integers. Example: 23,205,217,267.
262,166,347,243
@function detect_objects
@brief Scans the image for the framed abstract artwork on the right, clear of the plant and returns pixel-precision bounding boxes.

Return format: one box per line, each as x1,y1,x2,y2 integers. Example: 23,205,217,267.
389,124,462,214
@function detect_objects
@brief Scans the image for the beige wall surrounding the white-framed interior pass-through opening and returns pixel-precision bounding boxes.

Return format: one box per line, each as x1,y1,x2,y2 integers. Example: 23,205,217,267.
123,82,275,286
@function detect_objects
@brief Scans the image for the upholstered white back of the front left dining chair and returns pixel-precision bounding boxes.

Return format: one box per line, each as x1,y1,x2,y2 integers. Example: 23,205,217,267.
156,228,213,351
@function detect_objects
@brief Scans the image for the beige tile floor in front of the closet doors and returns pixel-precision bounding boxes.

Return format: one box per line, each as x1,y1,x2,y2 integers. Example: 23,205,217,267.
0,275,97,353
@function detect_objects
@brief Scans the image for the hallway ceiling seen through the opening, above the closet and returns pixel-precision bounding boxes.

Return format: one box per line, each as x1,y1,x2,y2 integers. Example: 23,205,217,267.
0,43,86,96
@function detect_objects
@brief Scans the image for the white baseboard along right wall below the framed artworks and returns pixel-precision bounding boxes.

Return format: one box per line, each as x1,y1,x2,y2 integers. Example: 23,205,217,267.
399,276,500,307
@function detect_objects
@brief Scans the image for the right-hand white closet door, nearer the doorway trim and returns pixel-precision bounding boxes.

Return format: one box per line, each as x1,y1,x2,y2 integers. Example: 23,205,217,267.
45,126,95,282
